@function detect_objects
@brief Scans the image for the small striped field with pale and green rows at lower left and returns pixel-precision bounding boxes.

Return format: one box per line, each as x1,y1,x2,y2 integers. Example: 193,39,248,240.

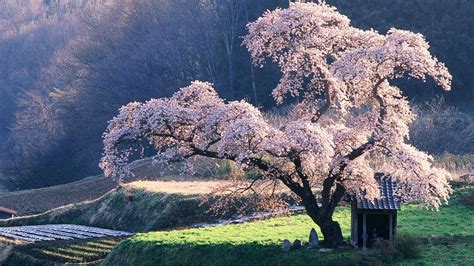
0,224,132,265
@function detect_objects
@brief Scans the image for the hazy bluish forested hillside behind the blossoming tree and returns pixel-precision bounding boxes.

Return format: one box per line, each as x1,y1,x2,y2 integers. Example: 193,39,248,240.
0,0,474,189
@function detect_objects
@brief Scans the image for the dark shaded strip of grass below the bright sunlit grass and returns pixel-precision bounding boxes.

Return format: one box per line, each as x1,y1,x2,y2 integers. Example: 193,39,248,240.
103,241,361,265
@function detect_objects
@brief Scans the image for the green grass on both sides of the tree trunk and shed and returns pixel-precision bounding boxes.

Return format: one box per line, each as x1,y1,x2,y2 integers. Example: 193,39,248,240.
103,189,474,265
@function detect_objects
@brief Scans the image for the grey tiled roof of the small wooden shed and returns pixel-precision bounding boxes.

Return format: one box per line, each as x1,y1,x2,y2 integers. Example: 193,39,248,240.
357,173,400,210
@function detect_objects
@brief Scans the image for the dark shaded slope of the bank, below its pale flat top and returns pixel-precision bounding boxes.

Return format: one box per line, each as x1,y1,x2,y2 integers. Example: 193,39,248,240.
0,186,226,232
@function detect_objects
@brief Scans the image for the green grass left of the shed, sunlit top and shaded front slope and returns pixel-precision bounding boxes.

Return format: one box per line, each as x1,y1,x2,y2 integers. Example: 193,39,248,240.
103,211,360,265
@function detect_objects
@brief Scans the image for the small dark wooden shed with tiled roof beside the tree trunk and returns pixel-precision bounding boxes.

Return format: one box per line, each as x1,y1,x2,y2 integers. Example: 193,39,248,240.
350,173,400,250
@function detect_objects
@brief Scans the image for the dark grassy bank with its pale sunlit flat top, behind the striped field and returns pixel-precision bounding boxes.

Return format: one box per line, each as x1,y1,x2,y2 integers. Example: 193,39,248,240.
0,179,286,232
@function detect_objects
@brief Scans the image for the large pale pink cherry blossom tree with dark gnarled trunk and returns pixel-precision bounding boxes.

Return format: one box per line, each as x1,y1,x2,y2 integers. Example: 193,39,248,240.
100,3,451,247
